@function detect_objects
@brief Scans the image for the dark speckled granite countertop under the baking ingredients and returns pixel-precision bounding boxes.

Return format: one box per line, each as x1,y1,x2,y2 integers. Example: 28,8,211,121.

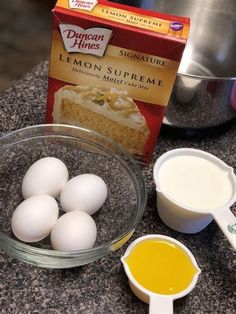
0,62,236,314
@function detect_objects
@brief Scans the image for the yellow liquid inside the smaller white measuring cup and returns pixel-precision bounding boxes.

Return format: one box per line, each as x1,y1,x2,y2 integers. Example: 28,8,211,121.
125,239,198,295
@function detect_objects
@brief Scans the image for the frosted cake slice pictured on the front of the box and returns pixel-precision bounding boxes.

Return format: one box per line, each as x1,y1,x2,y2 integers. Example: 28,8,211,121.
52,85,150,155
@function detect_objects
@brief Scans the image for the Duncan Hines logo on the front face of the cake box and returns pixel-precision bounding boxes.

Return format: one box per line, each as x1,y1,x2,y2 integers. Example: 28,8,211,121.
59,24,112,57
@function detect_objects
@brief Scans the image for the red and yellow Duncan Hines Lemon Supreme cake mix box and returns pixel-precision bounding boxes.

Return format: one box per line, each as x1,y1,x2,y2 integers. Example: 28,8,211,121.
46,0,189,163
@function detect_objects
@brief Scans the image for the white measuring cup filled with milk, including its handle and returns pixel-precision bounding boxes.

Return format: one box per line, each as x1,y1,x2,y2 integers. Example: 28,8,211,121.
153,148,236,250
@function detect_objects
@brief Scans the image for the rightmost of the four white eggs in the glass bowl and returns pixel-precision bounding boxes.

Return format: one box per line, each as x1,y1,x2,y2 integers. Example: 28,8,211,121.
60,174,107,215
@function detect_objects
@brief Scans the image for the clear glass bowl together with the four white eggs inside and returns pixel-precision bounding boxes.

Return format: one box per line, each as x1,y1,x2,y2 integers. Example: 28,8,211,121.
0,124,147,268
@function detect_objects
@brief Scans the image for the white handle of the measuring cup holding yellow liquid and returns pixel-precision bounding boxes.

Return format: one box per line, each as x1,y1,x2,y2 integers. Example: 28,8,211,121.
149,295,173,314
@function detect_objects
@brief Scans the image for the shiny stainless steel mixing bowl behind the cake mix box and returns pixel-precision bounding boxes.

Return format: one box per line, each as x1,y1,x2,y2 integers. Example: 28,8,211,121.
114,0,236,129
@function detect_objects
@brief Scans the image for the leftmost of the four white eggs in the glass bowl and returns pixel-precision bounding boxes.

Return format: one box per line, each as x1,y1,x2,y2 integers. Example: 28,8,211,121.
11,195,59,243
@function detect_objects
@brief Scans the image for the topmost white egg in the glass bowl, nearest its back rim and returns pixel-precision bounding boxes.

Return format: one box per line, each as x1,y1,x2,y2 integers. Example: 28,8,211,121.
22,157,69,198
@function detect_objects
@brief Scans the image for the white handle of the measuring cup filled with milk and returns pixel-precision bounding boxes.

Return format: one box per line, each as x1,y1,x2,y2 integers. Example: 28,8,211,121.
212,208,236,250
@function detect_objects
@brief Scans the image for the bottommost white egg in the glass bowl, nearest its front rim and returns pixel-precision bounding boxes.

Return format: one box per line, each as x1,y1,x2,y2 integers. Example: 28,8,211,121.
51,210,97,252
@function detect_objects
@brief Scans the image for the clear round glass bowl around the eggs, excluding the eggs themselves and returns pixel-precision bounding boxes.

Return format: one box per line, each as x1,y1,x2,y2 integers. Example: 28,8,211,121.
0,124,147,268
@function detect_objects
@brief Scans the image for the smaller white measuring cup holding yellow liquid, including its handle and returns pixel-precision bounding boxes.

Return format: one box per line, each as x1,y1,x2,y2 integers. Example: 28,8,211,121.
121,234,201,314
